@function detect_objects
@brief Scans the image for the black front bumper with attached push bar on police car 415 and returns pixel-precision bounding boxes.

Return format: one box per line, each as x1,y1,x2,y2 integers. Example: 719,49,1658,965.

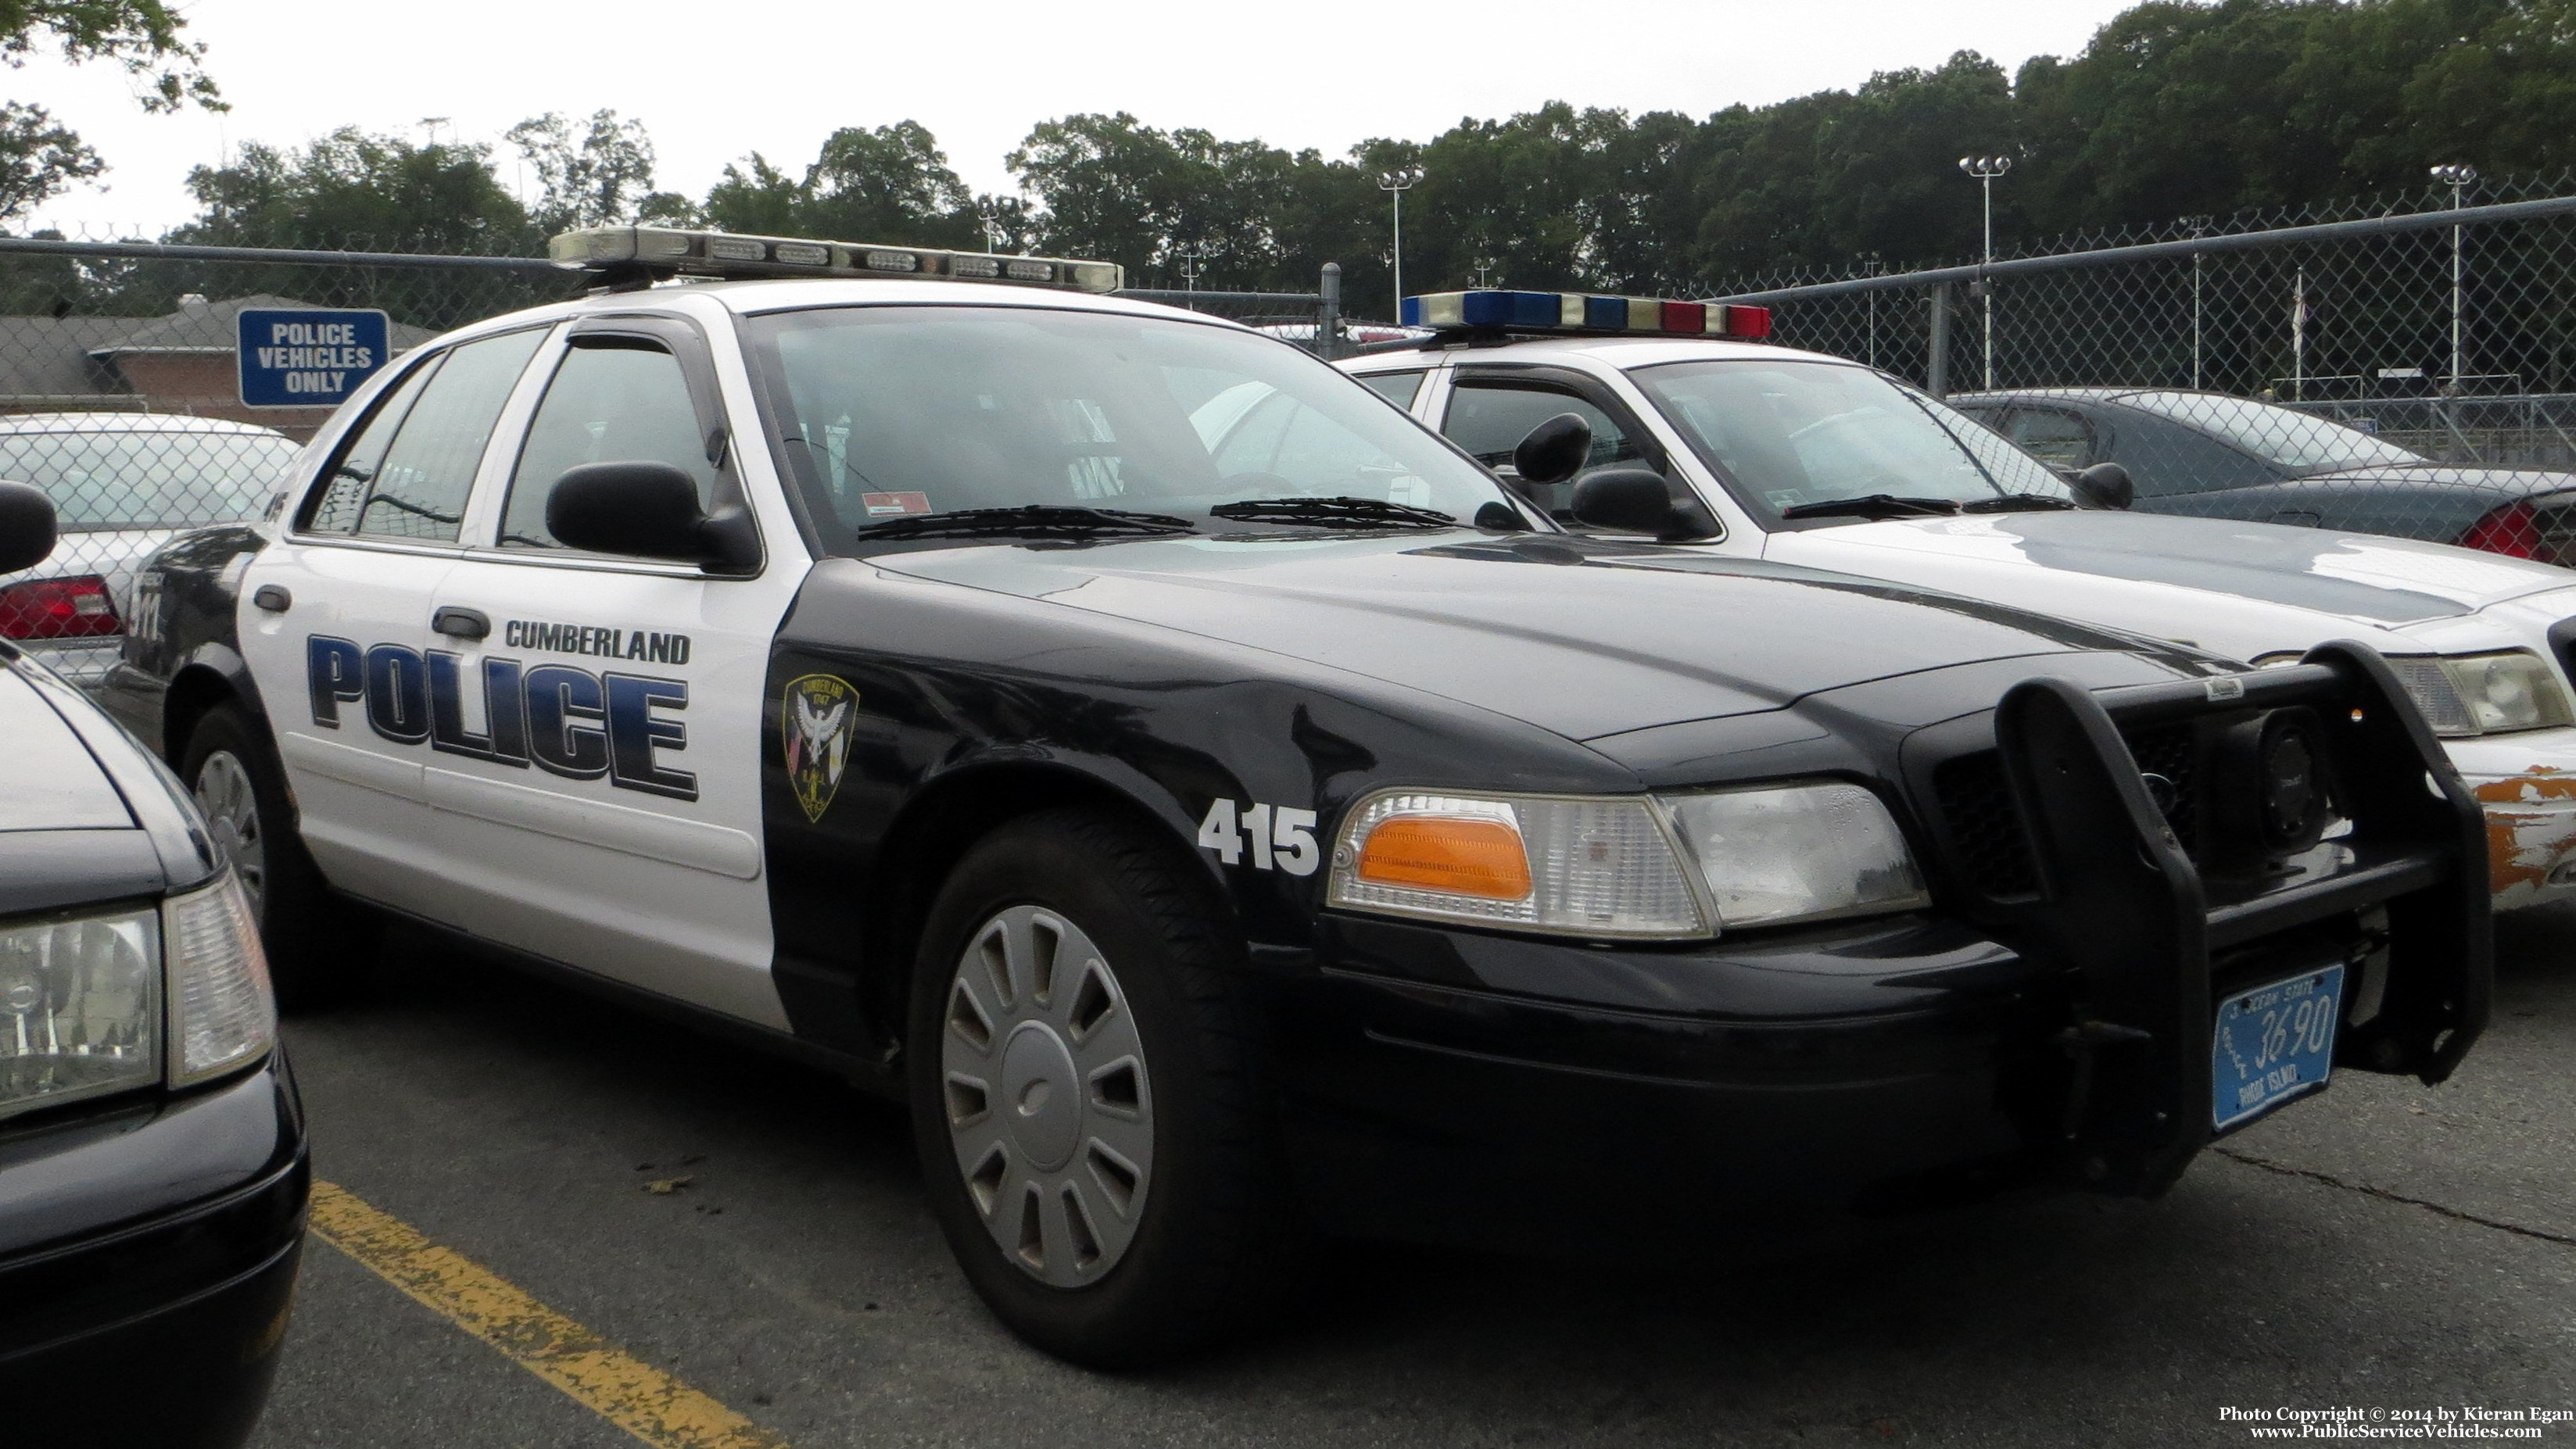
1273,646,2491,1254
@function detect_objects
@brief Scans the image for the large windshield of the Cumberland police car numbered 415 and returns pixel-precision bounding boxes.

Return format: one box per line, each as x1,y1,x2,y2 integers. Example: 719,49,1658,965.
752,306,1504,548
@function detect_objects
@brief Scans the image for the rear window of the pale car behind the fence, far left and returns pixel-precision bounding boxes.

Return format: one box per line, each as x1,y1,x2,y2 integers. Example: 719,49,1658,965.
0,430,304,533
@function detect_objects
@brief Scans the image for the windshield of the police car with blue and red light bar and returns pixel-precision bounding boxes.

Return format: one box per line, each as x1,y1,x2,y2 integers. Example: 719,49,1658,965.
1628,358,2073,520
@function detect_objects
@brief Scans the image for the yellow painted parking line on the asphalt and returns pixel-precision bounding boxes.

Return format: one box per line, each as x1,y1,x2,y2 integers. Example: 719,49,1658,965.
312,1182,788,1449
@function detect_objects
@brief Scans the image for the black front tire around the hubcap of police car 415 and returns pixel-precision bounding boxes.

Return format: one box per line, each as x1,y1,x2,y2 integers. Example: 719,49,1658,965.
907,810,1311,1369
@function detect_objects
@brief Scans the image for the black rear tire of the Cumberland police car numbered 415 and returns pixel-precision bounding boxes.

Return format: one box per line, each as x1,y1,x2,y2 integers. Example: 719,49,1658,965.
177,705,382,1011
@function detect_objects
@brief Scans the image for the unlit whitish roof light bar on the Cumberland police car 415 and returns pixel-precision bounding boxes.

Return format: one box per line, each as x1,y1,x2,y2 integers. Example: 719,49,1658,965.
546,227,1126,291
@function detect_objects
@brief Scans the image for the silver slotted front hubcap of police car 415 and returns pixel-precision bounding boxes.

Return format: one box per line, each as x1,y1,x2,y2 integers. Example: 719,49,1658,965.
940,906,1154,1287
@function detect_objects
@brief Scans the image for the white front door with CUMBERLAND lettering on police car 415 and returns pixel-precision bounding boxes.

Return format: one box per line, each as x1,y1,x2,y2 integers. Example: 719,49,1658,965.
425,317,806,1027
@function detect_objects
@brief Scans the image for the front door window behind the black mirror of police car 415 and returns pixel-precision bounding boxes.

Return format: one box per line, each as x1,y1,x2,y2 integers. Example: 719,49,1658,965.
500,337,716,548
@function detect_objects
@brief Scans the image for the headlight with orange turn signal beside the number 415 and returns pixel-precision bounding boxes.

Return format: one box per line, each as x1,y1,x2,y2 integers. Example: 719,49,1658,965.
1327,782,1929,939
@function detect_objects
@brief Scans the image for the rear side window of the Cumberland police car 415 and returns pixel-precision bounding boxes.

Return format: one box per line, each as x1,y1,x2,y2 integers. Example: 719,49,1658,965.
306,330,543,543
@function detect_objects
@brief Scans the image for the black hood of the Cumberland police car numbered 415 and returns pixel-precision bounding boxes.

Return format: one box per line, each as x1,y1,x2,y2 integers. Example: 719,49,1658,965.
871,533,2194,739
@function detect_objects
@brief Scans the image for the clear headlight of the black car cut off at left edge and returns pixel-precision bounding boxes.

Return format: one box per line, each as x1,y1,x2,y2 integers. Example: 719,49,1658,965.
0,911,163,1117
